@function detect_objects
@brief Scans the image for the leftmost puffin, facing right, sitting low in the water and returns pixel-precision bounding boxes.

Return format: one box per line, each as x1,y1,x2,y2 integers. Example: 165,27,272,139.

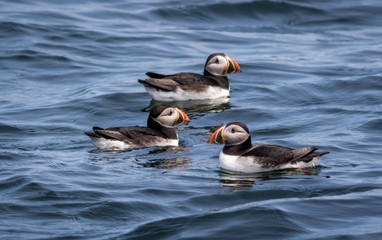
85,103,190,151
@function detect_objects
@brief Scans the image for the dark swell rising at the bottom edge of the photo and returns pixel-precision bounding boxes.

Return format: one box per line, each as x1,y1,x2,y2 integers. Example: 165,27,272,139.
118,204,307,239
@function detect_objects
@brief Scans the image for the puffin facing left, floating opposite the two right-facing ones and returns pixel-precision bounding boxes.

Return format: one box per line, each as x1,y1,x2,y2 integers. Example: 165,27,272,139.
207,122,329,173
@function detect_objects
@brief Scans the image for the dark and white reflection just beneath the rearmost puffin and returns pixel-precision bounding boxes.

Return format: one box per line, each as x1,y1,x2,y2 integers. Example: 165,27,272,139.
142,97,231,113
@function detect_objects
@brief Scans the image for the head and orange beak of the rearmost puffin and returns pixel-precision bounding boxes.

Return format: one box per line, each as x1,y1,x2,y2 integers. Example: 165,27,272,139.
204,53,241,76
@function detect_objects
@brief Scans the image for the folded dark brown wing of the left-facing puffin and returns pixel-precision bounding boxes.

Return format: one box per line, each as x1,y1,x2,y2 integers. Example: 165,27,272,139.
242,145,294,166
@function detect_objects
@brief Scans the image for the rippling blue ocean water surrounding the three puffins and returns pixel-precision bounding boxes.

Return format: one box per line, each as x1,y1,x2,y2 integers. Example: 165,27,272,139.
0,0,382,240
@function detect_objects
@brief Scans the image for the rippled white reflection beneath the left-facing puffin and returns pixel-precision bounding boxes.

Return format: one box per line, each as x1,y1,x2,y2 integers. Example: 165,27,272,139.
219,167,321,191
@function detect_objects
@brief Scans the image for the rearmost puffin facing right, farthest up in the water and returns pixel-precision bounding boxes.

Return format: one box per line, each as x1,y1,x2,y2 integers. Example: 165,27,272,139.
138,53,241,101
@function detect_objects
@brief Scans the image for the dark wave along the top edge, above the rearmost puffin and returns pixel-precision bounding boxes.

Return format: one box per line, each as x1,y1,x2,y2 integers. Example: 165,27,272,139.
151,1,326,26
